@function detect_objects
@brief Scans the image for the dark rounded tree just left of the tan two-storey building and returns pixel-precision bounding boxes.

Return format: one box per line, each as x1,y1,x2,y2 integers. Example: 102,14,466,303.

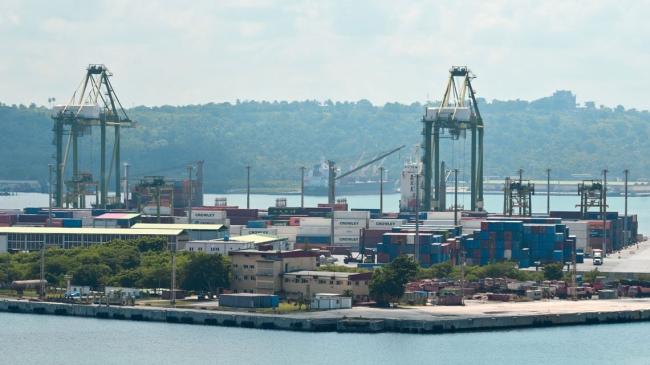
181,252,230,292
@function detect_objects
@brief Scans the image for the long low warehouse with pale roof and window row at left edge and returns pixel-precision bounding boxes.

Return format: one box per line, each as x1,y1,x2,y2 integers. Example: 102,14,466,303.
0,227,188,252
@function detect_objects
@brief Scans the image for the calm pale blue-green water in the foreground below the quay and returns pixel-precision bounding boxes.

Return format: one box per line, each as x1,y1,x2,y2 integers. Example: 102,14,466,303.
0,313,650,365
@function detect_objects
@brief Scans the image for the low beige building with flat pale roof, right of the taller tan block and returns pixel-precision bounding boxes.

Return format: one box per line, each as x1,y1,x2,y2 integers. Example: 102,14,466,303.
282,271,372,302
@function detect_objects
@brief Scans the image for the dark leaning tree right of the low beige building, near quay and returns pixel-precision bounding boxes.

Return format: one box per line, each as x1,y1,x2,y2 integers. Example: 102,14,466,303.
369,256,418,307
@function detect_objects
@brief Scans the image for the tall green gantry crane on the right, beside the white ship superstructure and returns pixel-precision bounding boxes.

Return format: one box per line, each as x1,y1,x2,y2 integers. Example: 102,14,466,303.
422,66,484,211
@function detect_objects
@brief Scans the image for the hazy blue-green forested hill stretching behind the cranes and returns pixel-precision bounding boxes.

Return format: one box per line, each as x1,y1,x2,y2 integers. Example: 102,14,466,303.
0,91,650,192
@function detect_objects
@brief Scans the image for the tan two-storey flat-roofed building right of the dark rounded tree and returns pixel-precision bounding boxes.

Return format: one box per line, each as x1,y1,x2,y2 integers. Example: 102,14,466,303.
230,250,318,294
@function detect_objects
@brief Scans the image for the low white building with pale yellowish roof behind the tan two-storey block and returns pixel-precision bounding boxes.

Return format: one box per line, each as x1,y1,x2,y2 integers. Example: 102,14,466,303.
185,234,289,256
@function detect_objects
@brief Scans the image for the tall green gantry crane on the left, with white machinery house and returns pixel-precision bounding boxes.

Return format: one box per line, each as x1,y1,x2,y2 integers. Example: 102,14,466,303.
52,64,135,207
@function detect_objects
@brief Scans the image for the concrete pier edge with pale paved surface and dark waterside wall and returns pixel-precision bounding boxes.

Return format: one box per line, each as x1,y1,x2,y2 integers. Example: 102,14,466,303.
0,299,650,333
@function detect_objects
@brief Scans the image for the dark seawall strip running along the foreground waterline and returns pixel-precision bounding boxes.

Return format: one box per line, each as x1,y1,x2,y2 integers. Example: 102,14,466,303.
0,299,650,333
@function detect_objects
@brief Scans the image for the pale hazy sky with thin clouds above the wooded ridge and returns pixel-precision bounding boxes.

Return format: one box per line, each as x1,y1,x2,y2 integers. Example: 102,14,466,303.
0,0,650,109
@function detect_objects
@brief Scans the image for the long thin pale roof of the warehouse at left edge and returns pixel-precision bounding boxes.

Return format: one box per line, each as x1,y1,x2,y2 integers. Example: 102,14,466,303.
0,227,184,236
